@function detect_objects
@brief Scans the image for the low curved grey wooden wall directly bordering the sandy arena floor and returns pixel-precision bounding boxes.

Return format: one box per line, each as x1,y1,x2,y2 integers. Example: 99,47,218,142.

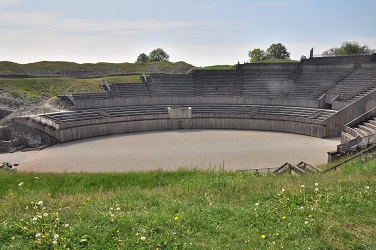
15,114,326,142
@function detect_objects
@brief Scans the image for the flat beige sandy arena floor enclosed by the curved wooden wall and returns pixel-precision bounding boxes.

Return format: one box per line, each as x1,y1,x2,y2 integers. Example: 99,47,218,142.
0,130,340,172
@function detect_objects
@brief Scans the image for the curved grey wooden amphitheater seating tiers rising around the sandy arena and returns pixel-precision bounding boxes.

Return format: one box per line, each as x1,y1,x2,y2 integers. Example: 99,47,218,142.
7,53,376,172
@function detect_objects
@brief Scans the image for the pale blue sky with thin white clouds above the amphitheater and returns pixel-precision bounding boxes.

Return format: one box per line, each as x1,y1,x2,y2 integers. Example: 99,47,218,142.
0,0,376,66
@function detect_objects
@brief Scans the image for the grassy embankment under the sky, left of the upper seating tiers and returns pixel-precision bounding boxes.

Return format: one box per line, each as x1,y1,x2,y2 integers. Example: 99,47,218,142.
0,62,193,103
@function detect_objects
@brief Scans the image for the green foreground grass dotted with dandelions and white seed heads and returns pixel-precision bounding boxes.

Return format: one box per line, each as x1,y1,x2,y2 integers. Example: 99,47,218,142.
0,161,376,249
